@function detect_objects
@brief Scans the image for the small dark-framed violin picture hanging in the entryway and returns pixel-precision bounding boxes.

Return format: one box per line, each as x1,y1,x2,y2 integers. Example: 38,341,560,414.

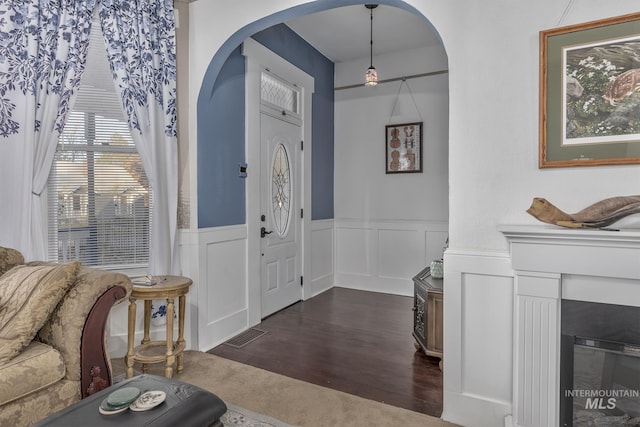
385,122,422,174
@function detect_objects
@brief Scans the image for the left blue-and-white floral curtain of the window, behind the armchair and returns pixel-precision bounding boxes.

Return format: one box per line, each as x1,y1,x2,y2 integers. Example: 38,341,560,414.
0,0,95,259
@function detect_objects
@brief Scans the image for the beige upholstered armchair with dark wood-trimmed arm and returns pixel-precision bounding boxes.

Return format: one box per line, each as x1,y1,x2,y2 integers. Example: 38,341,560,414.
0,247,132,426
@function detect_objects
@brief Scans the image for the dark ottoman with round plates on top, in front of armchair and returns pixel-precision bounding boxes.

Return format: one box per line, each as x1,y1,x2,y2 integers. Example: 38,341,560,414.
34,374,227,427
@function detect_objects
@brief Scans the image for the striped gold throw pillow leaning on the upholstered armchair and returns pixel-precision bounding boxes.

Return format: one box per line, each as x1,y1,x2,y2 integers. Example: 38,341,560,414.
0,262,80,364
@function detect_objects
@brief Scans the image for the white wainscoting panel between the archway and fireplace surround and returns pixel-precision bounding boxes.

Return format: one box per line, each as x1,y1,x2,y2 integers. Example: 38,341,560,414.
442,249,514,427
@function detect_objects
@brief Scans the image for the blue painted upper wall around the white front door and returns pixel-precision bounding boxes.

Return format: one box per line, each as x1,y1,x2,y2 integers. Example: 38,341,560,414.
197,24,334,228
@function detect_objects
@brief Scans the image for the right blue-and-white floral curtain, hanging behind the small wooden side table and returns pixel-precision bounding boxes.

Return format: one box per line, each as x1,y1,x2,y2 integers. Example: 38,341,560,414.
98,0,179,275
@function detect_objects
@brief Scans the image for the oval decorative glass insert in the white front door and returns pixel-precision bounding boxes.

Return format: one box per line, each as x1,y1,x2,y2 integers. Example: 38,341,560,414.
271,144,291,237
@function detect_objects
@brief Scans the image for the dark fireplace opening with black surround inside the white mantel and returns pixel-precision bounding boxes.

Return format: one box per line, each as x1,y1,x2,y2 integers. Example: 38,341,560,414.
560,300,640,427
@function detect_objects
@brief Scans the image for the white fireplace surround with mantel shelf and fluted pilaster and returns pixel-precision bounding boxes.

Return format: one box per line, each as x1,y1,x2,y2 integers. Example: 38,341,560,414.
499,225,640,426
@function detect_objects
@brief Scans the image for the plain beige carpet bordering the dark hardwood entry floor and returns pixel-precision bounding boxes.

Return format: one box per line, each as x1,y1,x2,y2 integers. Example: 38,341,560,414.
112,351,454,427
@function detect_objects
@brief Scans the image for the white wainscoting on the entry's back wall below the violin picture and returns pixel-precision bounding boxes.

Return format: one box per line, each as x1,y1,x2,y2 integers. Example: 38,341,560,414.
335,219,448,296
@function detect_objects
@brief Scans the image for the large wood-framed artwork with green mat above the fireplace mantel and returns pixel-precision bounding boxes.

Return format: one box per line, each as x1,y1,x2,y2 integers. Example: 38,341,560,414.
538,13,640,168
